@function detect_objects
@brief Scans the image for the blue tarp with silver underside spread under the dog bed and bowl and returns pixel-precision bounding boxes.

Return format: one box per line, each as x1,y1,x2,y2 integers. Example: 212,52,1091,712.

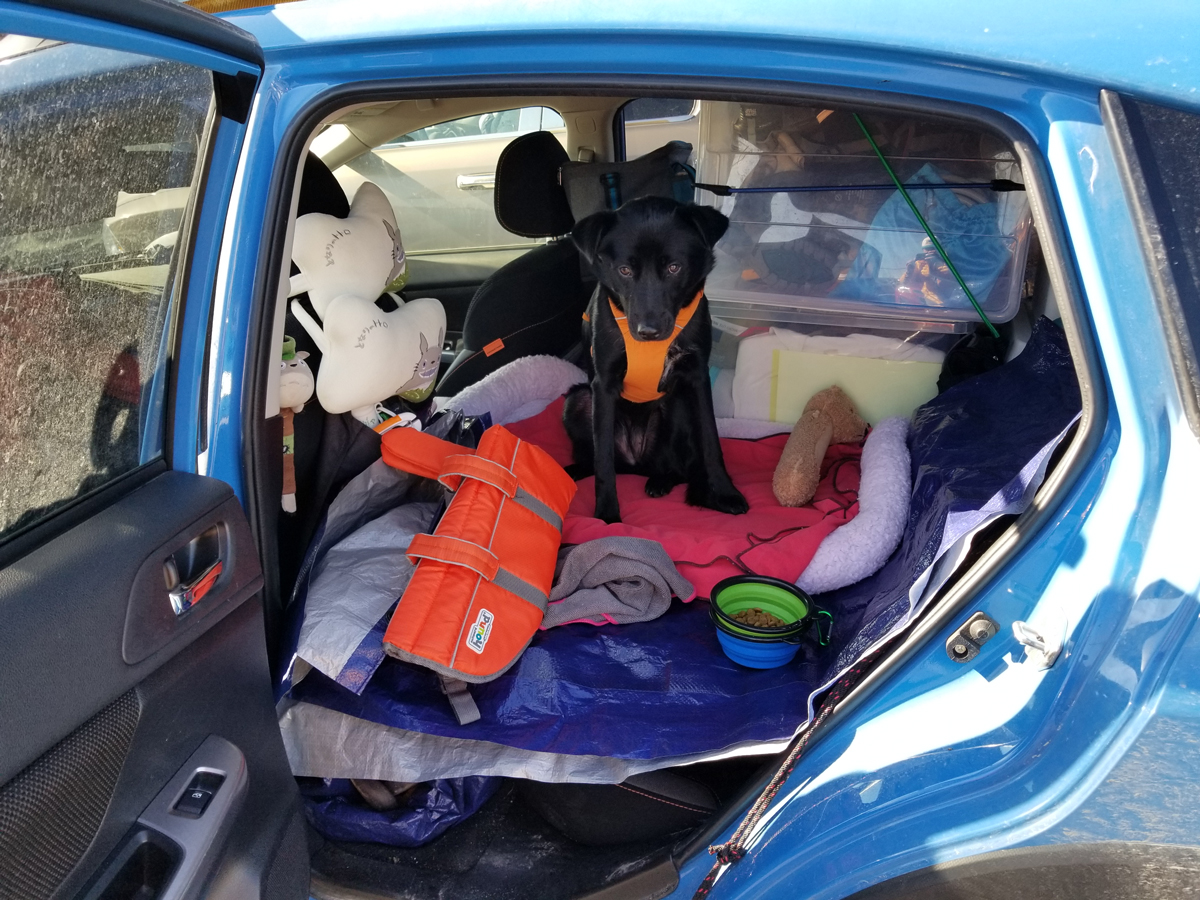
281,320,1080,781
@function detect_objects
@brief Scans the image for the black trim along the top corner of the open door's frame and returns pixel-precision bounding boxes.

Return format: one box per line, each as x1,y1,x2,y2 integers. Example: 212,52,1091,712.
16,0,263,68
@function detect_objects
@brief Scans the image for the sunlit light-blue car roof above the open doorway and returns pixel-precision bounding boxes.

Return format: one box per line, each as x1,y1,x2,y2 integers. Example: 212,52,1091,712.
224,0,1200,112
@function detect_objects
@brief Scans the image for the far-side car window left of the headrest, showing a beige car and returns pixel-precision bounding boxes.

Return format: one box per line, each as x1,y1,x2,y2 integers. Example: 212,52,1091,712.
331,107,566,256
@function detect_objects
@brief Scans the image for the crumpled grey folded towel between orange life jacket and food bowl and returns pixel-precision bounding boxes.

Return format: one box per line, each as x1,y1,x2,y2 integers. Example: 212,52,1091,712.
541,538,695,629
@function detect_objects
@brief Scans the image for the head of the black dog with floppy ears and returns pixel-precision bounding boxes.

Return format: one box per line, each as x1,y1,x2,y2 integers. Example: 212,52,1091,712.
571,197,730,341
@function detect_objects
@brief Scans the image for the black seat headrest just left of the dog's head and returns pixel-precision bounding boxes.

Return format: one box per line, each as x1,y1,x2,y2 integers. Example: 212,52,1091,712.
496,131,575,238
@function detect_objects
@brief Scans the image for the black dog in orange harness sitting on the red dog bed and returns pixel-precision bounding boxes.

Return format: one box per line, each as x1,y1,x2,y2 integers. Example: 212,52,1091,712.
563,197,749,522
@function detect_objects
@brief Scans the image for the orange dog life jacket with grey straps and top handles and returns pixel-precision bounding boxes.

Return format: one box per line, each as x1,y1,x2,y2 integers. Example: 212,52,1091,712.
383,425,575,683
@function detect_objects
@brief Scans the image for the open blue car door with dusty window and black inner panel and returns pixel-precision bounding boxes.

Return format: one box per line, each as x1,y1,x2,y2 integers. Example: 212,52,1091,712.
0,0,308,900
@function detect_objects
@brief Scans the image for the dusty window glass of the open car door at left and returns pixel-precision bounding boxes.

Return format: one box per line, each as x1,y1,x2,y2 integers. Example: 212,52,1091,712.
0,35,212,539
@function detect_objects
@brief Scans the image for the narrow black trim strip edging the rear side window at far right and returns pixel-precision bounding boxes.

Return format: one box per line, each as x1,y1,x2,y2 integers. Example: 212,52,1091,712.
1100,90,1200,438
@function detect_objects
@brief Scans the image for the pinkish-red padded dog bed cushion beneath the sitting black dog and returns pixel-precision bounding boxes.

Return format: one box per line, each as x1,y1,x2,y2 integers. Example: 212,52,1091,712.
505,400,863,600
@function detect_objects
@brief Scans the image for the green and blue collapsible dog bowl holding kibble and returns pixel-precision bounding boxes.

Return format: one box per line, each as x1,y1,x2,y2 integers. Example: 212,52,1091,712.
708,575,815,668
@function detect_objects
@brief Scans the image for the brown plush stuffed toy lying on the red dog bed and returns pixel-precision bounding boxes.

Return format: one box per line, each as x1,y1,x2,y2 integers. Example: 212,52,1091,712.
770,386,866,506
